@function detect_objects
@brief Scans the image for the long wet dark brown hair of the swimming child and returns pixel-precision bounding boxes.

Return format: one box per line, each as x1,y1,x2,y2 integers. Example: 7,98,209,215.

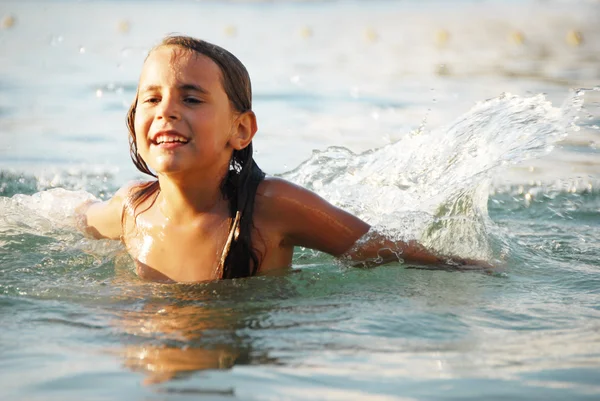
123,36,265,278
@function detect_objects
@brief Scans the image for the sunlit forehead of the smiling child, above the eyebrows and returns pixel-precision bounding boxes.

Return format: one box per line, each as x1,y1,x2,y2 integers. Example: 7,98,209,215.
140,46,222,89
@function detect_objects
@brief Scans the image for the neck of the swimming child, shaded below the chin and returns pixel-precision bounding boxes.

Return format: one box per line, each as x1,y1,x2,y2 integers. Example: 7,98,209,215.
157,166,229,223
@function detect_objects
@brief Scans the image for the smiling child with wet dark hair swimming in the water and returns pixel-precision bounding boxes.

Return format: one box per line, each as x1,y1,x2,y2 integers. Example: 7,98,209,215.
83,36,486,283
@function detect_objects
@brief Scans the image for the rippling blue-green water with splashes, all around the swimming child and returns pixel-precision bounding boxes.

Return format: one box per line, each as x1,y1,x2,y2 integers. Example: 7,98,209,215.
0,1,600,400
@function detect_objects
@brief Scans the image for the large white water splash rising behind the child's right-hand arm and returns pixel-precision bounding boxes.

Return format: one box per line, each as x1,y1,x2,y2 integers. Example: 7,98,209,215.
283,90,585,259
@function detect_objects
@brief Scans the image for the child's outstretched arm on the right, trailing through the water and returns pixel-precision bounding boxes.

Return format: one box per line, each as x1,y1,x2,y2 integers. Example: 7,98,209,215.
261,178,490,267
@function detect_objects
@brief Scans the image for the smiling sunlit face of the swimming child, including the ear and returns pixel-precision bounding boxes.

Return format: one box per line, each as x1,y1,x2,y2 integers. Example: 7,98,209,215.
134,46,237,175
